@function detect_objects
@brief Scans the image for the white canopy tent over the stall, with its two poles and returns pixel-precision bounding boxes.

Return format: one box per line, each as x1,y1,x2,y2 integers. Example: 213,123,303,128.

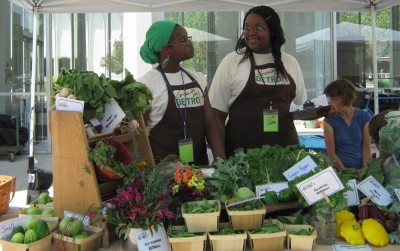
9,0,400,156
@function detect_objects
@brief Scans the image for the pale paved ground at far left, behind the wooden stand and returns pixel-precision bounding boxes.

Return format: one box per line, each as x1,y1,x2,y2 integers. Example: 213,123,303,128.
0,154,53,207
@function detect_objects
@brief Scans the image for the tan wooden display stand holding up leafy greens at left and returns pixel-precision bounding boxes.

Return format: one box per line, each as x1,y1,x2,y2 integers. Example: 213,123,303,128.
49,110,155,248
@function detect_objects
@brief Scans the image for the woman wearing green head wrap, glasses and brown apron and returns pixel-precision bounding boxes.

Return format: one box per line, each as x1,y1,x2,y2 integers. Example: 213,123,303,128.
138,21,225,165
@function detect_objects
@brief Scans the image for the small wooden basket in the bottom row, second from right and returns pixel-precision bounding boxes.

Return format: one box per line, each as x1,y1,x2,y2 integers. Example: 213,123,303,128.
247,220,286,251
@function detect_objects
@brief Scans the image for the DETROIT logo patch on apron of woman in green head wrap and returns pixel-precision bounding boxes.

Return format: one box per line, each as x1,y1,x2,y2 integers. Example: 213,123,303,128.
174,87,204,108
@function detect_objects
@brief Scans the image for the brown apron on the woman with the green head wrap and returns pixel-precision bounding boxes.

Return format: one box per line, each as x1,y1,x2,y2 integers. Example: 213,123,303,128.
149,66,208,165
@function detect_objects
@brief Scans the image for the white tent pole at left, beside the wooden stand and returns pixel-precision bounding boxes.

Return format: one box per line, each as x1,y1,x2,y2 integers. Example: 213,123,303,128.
29,7,38,157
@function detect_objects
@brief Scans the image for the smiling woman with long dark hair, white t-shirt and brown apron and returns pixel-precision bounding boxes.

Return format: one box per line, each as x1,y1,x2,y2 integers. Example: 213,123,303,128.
210,6,307,156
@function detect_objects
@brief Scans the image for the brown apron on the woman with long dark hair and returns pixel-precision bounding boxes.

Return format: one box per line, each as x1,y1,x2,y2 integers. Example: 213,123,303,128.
225,55,299,157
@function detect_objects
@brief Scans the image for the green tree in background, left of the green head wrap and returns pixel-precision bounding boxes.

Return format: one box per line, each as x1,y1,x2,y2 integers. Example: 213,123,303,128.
100,36,124,75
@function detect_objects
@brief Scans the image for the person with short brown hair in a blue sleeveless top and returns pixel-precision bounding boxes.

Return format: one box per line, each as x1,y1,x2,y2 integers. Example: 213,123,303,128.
324,79,371,170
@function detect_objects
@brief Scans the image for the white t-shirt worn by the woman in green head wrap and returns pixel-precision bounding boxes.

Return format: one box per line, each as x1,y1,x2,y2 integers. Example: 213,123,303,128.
137,64,207,133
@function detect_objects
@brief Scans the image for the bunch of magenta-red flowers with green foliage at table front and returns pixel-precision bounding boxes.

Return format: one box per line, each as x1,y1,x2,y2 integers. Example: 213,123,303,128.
89,166,174,239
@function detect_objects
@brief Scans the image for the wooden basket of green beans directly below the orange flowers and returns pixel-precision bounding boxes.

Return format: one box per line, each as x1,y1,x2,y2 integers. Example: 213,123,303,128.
181,200,221,233
